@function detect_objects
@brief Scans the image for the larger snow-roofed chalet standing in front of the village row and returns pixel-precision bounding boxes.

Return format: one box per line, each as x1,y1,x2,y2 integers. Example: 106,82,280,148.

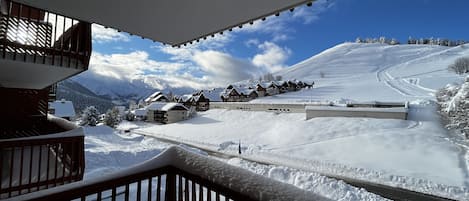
146,102,189,124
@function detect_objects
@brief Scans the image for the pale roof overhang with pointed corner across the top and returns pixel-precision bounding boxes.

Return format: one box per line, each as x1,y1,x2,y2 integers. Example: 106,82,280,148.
14,0,313,46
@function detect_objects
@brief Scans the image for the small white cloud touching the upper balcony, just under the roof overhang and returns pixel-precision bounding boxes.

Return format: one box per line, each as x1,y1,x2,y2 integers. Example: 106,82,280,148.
91,24,130,43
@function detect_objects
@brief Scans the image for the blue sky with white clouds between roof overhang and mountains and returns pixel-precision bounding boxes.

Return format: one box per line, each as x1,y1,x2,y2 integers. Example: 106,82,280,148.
87,0,469,88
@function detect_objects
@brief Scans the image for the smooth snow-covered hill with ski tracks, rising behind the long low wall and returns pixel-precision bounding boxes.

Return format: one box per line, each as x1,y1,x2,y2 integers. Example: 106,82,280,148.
262,43,469,101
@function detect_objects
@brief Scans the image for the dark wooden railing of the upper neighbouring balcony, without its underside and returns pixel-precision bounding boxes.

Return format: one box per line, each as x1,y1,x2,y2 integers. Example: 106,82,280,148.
0,0,91,70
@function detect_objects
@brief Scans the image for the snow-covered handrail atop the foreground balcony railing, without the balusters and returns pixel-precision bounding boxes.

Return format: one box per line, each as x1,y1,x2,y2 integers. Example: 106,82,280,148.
6,146,328,201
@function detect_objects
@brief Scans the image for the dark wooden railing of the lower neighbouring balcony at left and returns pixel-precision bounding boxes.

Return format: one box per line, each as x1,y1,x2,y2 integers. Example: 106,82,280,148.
0,118,85,199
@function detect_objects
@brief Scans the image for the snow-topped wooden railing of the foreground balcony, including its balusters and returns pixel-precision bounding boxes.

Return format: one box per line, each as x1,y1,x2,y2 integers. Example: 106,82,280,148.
9,147,328,201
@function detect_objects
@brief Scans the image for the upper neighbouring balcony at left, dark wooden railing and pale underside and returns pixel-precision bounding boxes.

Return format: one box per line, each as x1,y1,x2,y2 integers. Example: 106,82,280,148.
0,0,91,89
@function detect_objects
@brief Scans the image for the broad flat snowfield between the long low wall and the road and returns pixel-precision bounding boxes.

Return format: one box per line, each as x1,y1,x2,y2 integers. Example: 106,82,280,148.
136,107,469,198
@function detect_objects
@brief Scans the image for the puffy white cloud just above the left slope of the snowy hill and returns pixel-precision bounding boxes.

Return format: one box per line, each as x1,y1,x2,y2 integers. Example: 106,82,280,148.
252,42,292,72
